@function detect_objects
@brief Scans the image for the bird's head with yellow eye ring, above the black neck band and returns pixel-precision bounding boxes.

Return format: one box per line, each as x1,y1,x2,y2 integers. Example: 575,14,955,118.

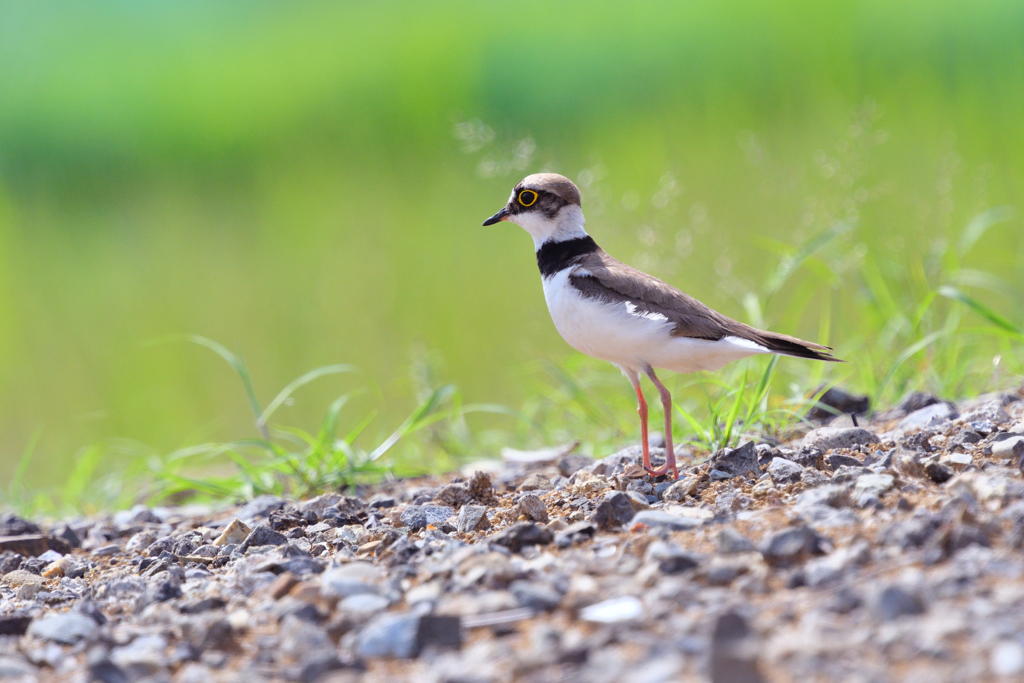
483,173,586,247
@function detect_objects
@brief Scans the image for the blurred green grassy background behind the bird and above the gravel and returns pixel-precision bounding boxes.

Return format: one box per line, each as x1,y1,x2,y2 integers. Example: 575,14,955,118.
0,0,1024,497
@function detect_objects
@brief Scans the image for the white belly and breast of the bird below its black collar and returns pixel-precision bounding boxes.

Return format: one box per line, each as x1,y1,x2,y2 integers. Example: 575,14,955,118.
543,270,769,373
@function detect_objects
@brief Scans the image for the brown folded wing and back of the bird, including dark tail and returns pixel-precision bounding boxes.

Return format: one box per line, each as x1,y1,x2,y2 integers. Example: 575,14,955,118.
569,249,838,360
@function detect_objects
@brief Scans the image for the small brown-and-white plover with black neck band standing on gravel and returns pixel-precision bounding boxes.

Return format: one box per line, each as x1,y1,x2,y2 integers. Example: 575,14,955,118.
483,173,843,479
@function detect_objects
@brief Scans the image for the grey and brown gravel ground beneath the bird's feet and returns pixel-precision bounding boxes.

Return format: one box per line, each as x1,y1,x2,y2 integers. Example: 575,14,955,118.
0,391,1024,683
